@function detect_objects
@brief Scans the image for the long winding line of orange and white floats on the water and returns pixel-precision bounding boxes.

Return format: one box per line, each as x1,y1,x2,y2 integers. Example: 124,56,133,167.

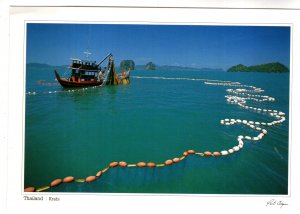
24,77,286,192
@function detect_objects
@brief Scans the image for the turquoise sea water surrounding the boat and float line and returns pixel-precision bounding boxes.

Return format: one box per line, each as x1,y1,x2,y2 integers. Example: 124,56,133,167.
24,66,289,194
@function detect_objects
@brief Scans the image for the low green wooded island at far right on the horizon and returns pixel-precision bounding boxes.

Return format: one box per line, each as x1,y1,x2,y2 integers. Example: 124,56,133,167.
227,62,289,73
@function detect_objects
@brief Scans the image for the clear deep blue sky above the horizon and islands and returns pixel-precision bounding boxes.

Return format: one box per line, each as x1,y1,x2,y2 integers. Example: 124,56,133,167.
26,23,290,69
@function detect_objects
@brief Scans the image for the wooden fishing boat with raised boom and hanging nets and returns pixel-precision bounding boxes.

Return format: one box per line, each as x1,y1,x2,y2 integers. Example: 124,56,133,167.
54,52,130,88
